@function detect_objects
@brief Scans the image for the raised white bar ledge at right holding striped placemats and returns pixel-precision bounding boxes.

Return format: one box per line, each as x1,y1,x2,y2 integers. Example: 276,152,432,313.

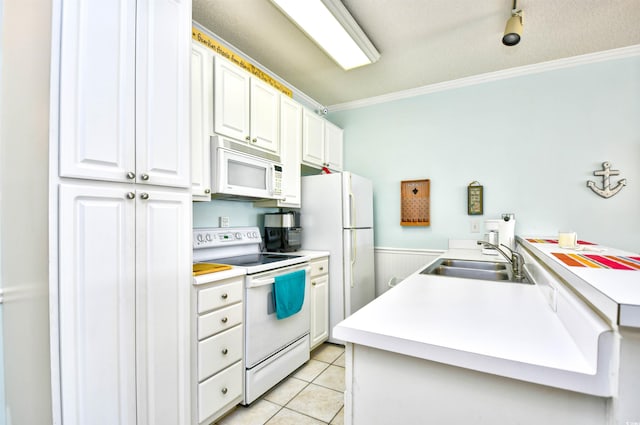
520,237,640,327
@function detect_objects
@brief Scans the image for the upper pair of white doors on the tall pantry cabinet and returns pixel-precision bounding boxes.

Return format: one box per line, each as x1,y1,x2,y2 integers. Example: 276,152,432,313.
59,0,191,187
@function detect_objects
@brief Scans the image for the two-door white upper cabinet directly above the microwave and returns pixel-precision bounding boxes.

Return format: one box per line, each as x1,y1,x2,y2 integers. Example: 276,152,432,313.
213,57,280,155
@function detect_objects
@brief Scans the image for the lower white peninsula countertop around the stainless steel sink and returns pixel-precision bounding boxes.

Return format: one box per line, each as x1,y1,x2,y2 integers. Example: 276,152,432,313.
334,249,613,396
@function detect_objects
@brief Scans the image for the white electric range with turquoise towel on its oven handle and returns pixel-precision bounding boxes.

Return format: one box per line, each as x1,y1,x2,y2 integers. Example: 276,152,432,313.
193,227,310,404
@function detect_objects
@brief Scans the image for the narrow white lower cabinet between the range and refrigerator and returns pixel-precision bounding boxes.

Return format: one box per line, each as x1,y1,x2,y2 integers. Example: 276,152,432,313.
309,257,329,350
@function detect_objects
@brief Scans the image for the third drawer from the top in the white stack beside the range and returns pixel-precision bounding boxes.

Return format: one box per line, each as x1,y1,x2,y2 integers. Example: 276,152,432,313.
198,325,242,381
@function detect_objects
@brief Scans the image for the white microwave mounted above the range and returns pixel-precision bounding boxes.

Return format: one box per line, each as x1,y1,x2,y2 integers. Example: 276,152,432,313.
211,143,284,199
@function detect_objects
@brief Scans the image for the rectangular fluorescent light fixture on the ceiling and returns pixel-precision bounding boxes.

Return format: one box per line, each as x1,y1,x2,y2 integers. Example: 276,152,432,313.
271,0,380,70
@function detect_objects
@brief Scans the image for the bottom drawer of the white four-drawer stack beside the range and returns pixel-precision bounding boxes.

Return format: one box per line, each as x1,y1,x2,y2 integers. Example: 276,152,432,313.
198,362,242,423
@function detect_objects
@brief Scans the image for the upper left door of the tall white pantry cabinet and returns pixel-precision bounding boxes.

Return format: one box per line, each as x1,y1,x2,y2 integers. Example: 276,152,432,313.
59,0,136,181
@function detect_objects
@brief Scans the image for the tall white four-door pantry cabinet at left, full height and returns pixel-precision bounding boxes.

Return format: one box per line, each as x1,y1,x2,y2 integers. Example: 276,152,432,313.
51,0,192,425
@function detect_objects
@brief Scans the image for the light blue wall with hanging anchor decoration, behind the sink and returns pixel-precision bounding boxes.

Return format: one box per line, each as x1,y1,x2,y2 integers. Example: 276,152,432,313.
329,57,640,252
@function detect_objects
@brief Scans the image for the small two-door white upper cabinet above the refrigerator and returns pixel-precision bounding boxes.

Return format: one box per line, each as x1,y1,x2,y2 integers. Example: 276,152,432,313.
302,109,343,171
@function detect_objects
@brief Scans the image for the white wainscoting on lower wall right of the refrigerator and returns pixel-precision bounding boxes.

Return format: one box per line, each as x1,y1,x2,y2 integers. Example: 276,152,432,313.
375,248,445,297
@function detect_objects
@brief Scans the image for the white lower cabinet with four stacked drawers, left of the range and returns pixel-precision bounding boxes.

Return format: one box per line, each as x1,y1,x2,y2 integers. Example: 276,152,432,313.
192,276,244,424
